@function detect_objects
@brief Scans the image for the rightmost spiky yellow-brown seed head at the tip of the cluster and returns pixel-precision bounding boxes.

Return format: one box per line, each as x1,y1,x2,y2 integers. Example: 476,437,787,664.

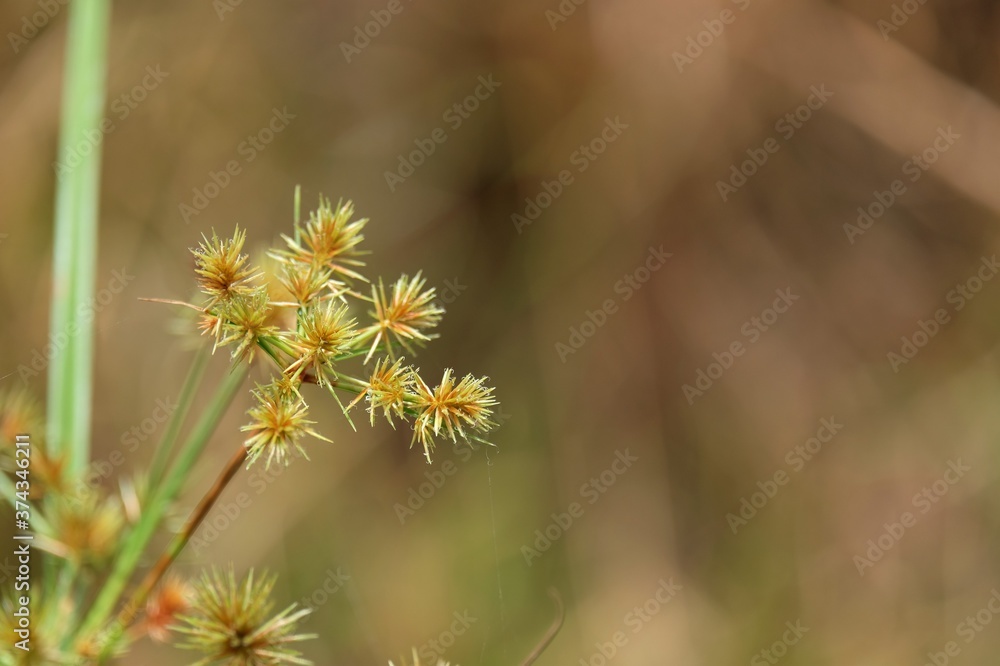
411,368,497,462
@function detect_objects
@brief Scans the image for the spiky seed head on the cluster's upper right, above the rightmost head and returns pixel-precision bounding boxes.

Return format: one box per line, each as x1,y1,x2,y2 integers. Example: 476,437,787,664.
360,272,444,363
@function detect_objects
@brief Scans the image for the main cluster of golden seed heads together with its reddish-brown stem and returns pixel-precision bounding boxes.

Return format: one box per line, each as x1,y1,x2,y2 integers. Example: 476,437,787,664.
99,192,497,663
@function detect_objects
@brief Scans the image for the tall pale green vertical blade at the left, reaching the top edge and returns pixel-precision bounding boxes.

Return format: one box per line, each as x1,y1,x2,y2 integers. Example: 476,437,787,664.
46,0,111,477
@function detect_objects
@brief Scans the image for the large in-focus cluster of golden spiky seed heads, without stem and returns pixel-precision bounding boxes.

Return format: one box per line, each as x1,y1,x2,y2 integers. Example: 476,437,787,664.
178,192,497,466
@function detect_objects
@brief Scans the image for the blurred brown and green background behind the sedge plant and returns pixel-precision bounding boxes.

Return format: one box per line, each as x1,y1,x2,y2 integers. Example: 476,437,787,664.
0,0,1000,666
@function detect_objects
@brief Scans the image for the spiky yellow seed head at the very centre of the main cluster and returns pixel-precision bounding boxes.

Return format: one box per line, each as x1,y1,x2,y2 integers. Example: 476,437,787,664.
285,301,356,384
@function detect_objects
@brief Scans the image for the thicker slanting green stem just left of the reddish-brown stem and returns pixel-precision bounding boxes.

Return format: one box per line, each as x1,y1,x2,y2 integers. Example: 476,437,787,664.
77,366,247,644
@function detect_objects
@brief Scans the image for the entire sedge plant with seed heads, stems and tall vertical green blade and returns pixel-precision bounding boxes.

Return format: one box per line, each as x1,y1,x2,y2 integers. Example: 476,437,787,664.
0,0,508,666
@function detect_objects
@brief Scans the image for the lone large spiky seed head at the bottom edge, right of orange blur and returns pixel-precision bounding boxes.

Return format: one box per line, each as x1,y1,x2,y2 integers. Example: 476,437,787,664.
172,566,316,666
